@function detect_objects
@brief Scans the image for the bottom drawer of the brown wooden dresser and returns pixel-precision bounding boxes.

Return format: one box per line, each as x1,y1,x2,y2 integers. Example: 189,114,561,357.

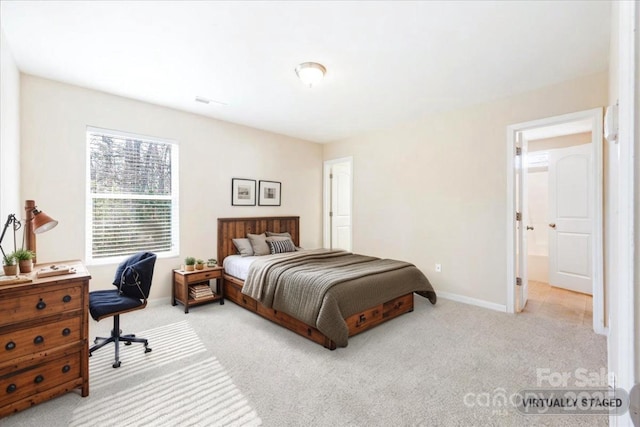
0,352,81,406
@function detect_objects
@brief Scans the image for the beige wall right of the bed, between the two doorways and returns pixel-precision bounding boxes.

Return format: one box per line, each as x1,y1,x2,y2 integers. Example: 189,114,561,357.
324,72,608,306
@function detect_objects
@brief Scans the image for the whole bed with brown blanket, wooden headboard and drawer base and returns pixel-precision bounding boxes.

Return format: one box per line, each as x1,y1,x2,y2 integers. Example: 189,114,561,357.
218,216,436,350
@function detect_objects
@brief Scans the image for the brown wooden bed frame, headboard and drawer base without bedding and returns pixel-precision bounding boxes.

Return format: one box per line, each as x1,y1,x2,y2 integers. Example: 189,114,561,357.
218,216,413,350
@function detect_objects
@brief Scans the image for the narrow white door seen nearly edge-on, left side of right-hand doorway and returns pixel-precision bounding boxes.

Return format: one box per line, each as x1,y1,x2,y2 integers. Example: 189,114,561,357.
516,132,529,311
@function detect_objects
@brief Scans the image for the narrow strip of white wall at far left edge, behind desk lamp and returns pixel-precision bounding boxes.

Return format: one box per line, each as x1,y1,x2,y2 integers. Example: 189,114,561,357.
0,28,24,224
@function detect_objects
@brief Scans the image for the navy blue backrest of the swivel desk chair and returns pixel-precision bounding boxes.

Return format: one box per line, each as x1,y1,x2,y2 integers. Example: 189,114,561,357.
113,252,157,300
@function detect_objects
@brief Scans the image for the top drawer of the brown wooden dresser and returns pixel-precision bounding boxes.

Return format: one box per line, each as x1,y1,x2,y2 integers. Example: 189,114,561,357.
0,285,82,326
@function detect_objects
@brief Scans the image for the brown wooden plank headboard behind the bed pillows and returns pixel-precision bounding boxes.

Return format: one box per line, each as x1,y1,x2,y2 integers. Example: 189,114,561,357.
218,216,300,265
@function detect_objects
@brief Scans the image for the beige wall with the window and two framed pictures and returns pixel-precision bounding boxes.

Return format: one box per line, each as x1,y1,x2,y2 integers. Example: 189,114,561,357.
21,75,322,298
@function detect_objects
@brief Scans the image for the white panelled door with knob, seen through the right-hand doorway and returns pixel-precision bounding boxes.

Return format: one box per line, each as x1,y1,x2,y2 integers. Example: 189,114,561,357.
549,144,593,294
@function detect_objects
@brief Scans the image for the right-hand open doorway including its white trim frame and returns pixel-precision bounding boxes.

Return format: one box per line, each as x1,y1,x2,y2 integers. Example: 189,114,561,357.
507,109,606,333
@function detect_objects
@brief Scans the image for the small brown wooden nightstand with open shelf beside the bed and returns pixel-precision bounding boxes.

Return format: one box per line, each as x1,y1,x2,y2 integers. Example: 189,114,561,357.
171,267,224,313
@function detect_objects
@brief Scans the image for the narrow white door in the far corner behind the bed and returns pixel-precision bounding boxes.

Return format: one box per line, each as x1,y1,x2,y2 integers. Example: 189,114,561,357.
324,158,352,251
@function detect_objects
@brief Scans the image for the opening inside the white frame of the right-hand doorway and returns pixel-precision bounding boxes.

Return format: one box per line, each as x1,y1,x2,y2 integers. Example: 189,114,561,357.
522,134,593,325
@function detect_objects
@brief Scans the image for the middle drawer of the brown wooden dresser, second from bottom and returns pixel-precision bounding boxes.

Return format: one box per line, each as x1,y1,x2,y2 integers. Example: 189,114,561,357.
0,316,82,365
